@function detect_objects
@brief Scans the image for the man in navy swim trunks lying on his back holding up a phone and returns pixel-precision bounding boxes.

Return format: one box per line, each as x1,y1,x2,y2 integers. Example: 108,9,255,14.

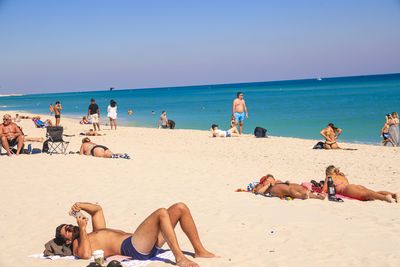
56,202,215,267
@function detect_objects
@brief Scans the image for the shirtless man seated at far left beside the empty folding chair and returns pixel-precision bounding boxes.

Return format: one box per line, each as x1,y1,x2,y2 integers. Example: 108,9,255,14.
0,114,24,156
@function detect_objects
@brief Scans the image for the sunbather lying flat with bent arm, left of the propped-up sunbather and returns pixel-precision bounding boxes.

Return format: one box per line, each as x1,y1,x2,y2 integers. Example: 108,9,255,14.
254,174,325,199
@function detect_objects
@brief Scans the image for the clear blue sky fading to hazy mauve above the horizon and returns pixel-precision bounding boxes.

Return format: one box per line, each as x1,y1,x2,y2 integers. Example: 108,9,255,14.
0,0,400,94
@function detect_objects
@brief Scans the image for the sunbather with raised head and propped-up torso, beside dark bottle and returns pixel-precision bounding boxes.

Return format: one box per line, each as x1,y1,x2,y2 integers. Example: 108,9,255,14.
322,165,399,203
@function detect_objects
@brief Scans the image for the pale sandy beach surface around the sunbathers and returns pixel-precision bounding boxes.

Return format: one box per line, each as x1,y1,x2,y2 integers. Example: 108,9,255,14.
0,111,400,267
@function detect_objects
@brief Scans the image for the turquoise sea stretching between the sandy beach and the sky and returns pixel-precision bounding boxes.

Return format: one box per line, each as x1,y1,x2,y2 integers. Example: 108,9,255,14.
0,74,400,144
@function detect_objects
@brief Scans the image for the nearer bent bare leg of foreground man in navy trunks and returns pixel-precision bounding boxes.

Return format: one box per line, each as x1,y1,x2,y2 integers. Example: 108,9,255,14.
132,208,199,267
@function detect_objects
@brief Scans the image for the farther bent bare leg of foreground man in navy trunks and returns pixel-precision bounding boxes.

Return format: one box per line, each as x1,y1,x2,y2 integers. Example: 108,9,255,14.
157,203,215,258
